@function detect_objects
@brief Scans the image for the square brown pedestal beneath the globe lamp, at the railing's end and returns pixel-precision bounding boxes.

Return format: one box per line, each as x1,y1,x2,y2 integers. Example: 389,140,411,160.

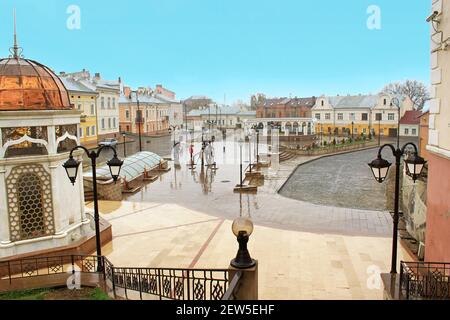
228,261,258,300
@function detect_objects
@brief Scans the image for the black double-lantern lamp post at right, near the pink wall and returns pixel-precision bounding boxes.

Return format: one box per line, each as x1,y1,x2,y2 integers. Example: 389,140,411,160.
369,142,426,274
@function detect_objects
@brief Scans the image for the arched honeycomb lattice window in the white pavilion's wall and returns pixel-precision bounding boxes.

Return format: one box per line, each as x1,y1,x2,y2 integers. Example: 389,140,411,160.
17,173,46,240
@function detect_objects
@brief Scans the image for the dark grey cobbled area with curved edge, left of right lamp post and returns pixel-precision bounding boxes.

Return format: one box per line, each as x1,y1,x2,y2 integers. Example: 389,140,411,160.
280,148,394,211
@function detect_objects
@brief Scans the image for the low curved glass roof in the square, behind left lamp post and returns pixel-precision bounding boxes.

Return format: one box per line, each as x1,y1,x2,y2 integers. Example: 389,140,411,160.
84,151,162,181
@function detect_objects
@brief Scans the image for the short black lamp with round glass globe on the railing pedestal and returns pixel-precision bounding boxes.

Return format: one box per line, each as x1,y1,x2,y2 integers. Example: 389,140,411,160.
230,217,256,269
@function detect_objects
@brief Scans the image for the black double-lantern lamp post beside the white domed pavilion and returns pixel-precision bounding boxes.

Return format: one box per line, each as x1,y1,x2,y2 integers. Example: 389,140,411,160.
63,146,123,272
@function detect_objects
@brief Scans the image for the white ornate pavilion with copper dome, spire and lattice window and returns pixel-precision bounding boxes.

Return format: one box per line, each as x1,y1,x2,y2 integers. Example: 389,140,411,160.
0,25,92,259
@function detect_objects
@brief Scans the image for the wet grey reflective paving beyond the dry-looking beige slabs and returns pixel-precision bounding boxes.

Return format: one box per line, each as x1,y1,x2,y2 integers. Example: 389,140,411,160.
118,137,391,236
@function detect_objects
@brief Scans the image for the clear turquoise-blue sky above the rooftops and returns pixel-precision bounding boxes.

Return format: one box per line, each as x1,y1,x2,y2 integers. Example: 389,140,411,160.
0,0,431,102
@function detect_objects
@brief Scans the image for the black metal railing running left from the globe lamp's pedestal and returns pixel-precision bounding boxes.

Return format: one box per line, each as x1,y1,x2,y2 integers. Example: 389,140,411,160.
0,255,241,300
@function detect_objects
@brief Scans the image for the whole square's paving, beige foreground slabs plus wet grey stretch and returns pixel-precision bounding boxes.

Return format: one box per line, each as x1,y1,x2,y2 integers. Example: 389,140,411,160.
88,134,411,300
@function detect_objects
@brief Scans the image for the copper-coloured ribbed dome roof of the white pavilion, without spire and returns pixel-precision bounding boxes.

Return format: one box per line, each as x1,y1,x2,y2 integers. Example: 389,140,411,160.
0,56,73,111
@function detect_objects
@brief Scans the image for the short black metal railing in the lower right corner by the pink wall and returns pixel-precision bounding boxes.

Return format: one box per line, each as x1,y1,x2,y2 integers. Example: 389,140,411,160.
400,261,450,300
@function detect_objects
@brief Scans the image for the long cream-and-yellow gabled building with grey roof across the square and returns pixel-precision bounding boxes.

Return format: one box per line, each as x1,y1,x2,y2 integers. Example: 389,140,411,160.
311,93,413,137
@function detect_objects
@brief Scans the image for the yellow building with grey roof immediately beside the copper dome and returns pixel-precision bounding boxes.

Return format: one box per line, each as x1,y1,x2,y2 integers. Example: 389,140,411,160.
60,76,98,148
